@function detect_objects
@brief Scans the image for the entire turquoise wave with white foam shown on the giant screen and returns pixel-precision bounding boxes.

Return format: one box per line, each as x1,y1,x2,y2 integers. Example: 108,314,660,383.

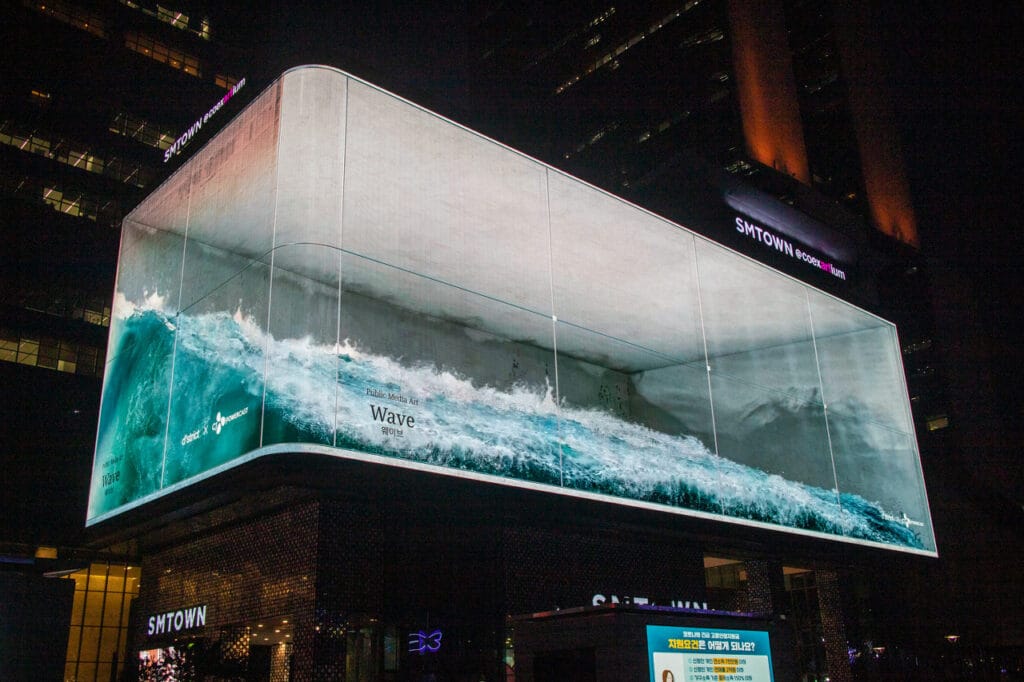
90,298,923,549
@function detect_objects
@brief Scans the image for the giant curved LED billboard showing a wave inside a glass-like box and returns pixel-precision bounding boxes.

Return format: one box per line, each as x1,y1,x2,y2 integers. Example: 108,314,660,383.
88,67,935,554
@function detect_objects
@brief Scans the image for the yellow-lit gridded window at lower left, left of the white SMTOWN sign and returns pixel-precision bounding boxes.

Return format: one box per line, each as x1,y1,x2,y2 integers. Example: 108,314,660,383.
65,562,140,682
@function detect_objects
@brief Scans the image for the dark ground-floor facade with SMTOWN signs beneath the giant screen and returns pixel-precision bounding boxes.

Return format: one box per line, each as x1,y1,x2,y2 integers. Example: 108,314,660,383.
108,450,851,682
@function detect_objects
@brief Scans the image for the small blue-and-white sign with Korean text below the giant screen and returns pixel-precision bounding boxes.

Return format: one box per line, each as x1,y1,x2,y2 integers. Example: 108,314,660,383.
647,626,775,682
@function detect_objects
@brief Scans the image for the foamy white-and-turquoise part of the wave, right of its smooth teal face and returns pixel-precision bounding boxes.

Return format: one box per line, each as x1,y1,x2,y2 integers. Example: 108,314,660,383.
121,303,925,542
